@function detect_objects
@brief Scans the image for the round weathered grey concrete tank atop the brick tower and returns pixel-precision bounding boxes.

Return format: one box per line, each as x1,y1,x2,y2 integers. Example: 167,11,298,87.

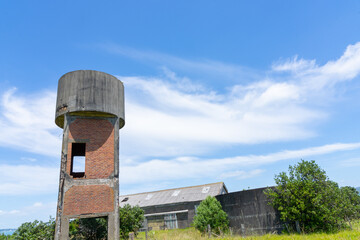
55,70,125,128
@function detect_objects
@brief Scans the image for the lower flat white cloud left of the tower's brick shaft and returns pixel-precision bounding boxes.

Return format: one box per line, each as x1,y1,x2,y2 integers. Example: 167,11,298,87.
0,165,60,195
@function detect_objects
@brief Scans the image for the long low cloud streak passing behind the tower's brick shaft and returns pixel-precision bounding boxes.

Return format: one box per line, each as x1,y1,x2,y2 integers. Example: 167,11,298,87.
0,143,360,196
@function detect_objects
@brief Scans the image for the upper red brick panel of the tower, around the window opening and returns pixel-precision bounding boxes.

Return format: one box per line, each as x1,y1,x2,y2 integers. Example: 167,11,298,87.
66,118,114,179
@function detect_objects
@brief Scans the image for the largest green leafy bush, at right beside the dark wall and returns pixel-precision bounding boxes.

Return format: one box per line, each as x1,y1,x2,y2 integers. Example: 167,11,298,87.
265,160,360,233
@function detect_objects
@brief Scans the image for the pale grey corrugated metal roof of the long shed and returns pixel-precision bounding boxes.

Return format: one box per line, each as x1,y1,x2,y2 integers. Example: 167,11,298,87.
119,182,227,207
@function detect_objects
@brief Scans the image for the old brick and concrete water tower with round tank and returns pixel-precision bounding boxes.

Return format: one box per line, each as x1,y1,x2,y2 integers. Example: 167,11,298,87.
55,70,125,240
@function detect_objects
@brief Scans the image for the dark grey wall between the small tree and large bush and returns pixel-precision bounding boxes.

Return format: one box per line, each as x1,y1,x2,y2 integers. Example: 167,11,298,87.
216,188,282,235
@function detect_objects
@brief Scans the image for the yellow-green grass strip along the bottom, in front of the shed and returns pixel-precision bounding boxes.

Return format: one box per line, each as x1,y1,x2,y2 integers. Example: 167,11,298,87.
137,221,360,240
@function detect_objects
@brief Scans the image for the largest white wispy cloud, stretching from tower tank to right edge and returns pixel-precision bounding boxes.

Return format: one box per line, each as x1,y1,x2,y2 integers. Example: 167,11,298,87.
119,43,360,156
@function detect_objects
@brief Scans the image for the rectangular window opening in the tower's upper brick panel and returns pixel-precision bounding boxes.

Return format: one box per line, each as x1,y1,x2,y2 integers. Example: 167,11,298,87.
70,143,86,178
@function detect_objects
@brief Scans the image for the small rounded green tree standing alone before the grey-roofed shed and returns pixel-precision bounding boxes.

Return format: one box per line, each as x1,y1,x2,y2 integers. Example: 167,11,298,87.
193,196,229,233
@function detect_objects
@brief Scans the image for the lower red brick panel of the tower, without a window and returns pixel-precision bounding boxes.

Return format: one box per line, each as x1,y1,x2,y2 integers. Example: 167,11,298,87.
63,185,114,215
